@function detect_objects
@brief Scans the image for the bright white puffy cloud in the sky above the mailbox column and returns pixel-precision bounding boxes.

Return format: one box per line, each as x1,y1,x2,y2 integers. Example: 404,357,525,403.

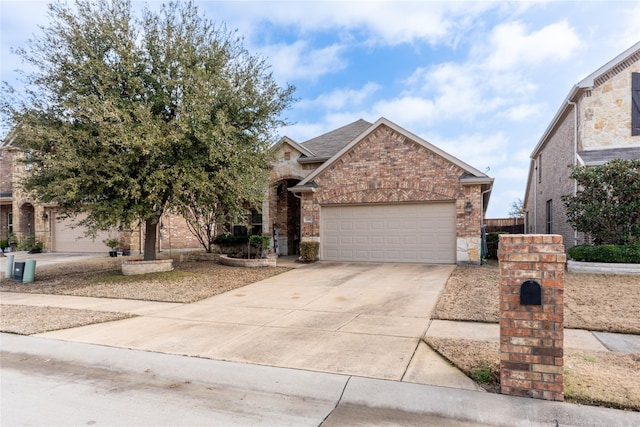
479,21,580,70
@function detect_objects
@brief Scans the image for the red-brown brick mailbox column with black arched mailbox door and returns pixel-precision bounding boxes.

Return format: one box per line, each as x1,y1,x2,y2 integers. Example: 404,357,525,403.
498,234,566,401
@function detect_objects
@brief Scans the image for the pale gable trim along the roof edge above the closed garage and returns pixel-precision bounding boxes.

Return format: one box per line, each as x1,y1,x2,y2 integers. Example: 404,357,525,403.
298,117,493,190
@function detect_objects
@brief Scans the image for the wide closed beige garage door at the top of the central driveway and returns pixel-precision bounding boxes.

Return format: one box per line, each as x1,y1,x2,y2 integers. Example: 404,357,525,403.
320,203,456,264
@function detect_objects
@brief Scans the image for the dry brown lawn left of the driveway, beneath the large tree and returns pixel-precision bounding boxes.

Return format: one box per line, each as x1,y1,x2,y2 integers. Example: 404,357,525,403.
0,257,289,335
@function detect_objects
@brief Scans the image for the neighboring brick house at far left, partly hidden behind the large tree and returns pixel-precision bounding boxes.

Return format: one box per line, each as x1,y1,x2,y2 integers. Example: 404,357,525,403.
0,132,200,254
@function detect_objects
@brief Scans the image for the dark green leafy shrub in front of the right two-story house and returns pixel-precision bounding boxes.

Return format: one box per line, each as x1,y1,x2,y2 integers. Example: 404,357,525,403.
562,159,640,244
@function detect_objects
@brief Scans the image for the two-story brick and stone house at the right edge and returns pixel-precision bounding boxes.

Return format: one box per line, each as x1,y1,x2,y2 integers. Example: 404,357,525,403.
524,42,640,249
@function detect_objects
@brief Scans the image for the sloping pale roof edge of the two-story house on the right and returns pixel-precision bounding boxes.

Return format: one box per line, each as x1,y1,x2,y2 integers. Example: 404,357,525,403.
531,42,640,159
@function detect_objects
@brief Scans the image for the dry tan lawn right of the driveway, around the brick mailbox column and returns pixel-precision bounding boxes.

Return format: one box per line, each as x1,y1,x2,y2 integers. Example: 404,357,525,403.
425,263,640,411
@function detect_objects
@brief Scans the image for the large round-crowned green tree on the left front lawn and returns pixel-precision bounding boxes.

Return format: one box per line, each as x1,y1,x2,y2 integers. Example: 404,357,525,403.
3,0,294,260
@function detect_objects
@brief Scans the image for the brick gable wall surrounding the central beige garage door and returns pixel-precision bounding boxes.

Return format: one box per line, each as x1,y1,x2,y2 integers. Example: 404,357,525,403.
301,126,482,262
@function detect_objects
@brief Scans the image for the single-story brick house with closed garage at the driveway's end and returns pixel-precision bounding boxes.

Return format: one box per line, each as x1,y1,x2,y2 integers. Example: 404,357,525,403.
262,118,493,263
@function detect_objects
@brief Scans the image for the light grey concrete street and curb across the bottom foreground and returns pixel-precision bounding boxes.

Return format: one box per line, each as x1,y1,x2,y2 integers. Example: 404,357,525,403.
0,334,640,427
